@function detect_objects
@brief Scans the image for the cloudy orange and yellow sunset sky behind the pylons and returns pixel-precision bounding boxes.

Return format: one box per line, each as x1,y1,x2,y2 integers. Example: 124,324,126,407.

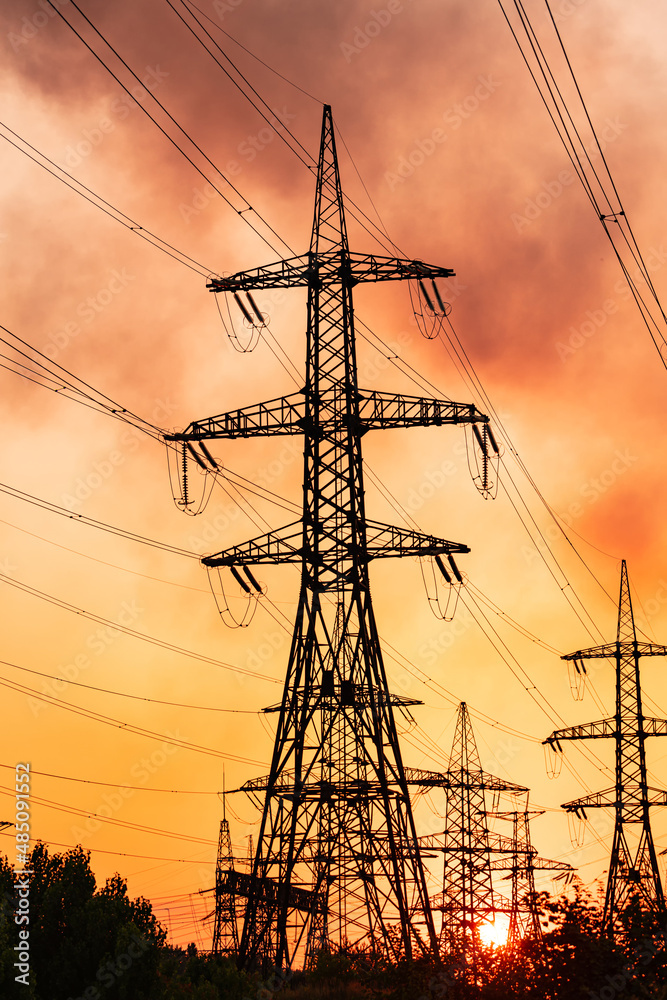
0,0,667,946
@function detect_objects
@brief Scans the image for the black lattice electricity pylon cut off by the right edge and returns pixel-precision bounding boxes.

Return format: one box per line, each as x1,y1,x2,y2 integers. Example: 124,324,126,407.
545,560,667,938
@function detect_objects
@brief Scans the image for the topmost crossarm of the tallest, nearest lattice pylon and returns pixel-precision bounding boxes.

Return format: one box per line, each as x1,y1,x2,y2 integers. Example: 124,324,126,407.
206,250,455,292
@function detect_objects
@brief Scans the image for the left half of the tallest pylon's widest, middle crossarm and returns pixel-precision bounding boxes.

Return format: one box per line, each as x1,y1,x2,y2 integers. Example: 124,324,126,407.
164,392,305,441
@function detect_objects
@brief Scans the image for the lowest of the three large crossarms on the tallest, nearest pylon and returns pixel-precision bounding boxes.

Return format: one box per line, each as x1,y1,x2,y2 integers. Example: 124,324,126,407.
202,521,470,566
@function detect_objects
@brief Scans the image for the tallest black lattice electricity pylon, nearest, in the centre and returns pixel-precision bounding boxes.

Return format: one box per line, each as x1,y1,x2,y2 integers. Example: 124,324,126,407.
170,106,488,967
